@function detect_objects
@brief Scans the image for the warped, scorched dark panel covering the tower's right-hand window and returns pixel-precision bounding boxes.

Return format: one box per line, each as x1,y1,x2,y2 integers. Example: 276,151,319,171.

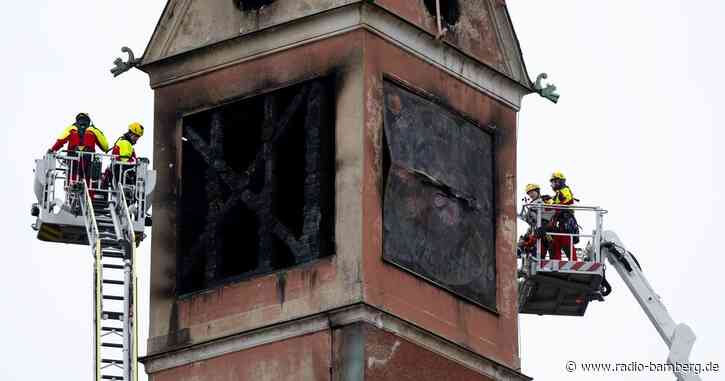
383,82,496,309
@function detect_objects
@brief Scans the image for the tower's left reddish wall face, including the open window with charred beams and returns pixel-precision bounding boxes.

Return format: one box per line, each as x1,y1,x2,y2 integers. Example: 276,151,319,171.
148,31,363,354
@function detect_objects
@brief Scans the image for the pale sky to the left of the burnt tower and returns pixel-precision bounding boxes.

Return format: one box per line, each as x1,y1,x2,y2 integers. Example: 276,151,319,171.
0,0,165,381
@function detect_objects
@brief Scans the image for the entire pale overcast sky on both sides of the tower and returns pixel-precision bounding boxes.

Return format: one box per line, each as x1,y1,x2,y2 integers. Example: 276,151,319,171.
0,0,725,381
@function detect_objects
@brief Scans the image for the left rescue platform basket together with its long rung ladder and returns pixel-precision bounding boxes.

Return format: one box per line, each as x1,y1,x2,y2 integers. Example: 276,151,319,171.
31,151,156,381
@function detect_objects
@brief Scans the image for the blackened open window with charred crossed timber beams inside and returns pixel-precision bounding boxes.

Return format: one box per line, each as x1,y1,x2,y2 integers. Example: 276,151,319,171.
177,75,334,294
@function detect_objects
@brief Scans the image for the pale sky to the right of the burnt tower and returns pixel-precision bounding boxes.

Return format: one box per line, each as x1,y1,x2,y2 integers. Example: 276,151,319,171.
508,0,725,380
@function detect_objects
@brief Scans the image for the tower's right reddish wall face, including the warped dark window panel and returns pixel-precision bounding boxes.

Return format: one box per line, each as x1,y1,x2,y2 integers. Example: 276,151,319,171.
363,34,519,368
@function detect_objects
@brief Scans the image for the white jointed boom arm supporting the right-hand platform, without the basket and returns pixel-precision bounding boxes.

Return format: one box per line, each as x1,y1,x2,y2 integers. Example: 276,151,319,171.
602,231,700,381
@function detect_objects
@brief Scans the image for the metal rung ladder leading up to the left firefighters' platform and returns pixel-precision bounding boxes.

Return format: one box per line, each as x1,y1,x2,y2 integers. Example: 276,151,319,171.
81,182,138,381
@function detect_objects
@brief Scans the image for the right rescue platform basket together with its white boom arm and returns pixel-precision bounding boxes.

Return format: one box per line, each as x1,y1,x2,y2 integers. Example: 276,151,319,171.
518,203,700,381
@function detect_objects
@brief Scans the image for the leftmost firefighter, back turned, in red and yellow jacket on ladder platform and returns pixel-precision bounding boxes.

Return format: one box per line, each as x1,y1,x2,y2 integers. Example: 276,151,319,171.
48,112,108,187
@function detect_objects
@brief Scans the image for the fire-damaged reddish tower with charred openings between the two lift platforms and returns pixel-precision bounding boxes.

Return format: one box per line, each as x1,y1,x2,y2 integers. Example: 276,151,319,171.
140,0,532,381
